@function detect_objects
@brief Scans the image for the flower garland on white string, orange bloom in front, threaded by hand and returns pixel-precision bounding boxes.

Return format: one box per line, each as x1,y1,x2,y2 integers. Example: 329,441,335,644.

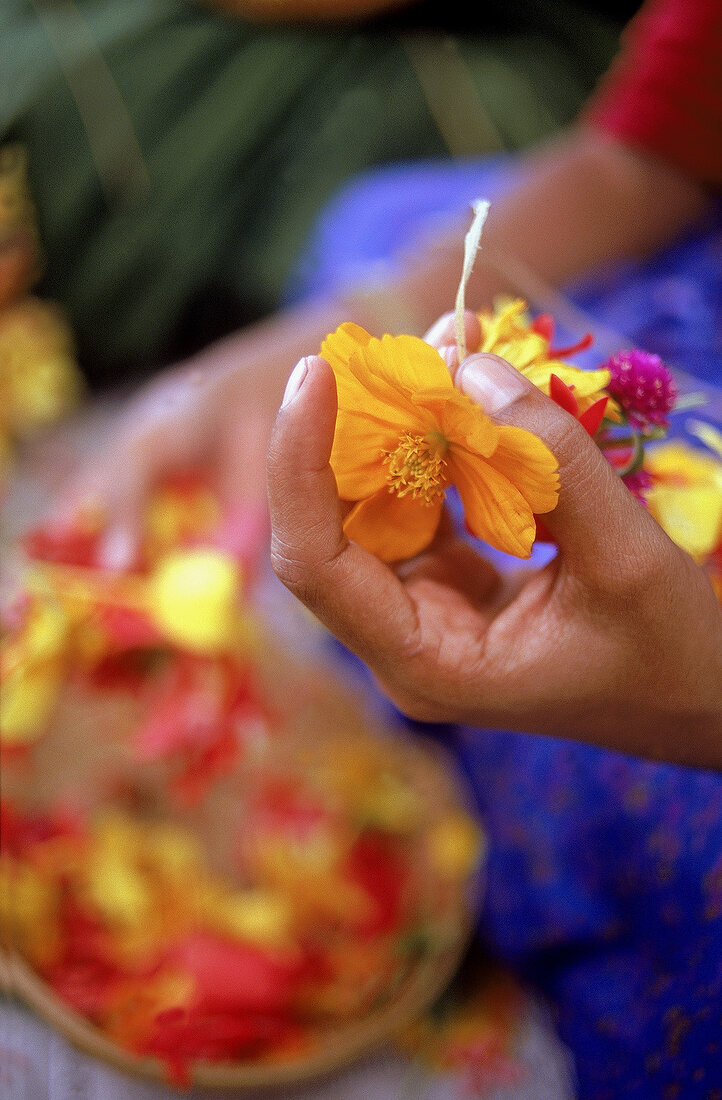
320,201,722,591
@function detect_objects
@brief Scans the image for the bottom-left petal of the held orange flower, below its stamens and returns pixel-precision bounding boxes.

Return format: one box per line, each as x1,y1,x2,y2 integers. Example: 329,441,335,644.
343,488,441,561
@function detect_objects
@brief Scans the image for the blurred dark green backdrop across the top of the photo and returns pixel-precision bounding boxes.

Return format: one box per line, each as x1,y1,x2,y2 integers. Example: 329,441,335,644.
0,0,617,385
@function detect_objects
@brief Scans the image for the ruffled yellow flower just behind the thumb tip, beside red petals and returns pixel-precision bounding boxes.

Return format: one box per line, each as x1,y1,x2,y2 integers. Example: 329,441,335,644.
479,298,616,419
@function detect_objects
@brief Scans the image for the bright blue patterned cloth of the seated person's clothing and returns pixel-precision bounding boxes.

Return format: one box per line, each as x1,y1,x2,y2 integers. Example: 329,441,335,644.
289,157,722,1100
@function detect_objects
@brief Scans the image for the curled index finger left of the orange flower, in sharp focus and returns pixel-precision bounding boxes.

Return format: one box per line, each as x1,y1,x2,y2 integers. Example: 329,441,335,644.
267,356,418,674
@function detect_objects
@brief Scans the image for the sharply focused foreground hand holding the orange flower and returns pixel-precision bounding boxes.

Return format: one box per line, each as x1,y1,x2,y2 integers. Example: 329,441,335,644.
267,321,722,768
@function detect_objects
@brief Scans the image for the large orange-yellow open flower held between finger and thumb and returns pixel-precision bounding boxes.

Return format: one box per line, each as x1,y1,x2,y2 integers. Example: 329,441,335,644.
321,323,558,561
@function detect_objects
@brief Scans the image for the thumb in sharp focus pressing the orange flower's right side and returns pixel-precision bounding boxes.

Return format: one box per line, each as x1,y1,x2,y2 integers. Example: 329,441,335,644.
456,353,668,585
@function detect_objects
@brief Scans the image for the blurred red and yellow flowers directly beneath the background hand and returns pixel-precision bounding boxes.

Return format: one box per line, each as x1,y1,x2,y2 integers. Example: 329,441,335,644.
0,475,267,802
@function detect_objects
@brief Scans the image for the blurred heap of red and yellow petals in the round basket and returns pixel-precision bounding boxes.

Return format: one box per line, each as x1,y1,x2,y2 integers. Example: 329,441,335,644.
0,730,484,1085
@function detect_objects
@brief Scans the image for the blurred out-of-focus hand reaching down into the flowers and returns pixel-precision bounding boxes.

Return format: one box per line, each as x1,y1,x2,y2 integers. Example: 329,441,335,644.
55,334,283,570
